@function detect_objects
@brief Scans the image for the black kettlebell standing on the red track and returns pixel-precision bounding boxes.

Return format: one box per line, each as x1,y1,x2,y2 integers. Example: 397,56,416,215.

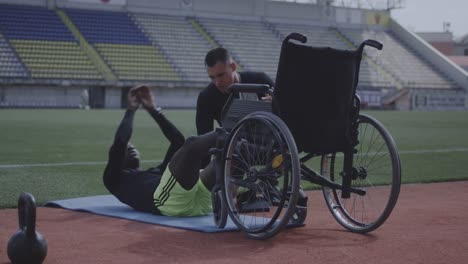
7,193,47,264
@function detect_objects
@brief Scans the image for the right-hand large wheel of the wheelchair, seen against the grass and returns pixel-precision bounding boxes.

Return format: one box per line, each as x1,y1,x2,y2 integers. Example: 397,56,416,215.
321,115,401,233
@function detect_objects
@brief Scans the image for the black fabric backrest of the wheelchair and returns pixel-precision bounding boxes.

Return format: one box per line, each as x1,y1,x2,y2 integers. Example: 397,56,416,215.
273,35,362,153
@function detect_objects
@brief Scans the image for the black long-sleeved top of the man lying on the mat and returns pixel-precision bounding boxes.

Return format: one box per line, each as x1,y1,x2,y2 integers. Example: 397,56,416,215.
103,109,185,212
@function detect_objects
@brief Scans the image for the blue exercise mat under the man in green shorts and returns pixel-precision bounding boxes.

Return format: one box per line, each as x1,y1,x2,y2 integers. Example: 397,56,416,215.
44,195,300,233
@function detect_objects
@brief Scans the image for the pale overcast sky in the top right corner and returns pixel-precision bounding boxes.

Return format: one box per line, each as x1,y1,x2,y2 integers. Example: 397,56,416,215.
392,0,468,37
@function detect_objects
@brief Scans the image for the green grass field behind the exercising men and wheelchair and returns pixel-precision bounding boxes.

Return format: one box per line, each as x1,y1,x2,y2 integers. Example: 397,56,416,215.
0,109,468,208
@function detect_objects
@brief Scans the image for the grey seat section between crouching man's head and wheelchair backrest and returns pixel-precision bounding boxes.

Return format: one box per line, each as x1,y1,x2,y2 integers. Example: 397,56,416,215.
197,17,281,80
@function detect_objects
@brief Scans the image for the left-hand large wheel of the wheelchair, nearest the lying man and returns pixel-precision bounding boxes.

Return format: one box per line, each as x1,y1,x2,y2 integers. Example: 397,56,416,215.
223,112,300,239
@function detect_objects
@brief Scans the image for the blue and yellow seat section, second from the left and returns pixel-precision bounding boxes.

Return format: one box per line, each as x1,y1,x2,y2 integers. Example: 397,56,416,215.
66,9,181,81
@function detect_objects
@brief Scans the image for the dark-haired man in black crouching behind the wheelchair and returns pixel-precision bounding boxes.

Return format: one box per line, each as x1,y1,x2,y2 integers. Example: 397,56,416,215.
196,48,274,135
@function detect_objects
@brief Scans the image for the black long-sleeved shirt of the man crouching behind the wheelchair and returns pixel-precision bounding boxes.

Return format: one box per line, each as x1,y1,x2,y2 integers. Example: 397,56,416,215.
196,72,274,135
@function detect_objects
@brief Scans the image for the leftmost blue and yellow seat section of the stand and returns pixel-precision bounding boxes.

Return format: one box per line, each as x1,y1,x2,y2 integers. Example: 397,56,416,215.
0,5,102,80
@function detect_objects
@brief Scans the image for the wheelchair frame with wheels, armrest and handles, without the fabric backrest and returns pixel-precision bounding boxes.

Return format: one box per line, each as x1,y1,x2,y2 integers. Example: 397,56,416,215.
211,33,401,239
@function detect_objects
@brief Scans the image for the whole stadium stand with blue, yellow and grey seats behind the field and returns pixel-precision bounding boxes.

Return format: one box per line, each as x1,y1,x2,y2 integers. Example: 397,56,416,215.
0,0,462,110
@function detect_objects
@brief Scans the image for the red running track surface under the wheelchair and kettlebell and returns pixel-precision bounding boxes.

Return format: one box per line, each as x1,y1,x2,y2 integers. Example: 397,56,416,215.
0,181,468,264
